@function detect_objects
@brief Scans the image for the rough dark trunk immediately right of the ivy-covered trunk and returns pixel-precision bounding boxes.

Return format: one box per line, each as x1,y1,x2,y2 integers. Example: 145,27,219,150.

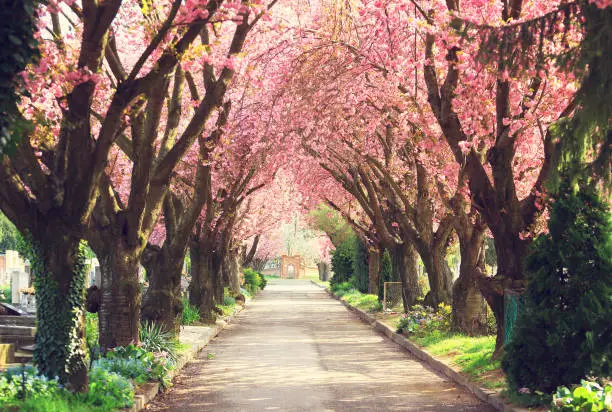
95,245,141,351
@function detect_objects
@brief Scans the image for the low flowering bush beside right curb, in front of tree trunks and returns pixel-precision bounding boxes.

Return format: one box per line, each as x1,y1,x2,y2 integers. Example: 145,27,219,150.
397,303,452,335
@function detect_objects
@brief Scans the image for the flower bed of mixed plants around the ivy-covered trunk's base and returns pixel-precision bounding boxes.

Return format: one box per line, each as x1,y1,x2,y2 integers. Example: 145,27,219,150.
0,314,180,412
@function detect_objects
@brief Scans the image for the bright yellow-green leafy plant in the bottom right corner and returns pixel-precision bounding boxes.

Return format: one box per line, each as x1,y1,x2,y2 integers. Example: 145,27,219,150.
552,380,612,412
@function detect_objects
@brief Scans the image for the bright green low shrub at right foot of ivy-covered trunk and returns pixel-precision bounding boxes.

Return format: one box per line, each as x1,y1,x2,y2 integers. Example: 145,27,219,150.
85,361,134,411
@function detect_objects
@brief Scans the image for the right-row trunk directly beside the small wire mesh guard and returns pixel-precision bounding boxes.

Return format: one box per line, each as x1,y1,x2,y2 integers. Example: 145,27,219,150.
391,244,422,312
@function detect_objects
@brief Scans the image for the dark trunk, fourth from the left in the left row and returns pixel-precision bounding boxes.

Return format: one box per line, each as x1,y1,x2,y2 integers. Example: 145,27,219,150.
189,243,218,323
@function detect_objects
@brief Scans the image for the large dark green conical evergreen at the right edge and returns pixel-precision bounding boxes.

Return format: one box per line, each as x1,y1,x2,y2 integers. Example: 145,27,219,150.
502,185,612,393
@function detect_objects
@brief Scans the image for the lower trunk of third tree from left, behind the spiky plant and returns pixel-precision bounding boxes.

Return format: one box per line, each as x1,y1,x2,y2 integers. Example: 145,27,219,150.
140,248,185,336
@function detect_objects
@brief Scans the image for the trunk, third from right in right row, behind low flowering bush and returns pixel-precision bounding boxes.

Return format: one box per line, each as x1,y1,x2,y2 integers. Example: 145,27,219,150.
419,245,453,308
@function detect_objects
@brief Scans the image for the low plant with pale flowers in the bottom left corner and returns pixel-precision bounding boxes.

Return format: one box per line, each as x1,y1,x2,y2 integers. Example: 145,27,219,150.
0,366,59,404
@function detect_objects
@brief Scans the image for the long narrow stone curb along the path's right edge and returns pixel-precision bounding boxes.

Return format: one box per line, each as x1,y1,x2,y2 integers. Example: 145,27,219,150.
311,281,529,412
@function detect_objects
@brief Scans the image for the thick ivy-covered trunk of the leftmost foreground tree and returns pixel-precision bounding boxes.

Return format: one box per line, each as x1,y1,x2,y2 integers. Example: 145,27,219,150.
29,232,88,392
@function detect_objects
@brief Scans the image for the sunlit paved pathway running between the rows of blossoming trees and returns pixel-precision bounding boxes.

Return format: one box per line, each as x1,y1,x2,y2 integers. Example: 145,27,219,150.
152,280,494,412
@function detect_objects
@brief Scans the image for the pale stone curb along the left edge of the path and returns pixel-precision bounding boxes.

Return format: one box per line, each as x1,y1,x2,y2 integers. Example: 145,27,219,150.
126,306,246,412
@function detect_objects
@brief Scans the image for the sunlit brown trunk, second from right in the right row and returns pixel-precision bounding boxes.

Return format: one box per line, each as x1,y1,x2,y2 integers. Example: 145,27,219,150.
452,228,487,336
